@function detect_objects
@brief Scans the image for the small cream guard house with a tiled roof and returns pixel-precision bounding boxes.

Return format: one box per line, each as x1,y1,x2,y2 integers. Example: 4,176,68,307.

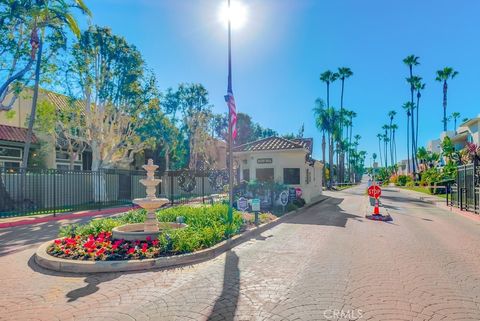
233,137,323,203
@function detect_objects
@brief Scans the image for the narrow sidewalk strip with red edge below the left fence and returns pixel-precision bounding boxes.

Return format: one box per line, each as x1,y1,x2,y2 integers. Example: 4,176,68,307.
0,205,139,228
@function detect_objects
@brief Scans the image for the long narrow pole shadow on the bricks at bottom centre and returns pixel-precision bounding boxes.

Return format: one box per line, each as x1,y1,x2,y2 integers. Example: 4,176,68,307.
208,251,240,321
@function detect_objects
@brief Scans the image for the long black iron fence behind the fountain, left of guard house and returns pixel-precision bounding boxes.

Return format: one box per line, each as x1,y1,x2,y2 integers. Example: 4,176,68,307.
0,167,228,217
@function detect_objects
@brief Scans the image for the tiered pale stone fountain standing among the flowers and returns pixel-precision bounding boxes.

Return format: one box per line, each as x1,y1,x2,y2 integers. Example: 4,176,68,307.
112,159,187,241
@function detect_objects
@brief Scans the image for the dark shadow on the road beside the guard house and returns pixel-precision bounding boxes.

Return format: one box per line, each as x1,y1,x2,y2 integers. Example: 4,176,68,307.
285,197,364,227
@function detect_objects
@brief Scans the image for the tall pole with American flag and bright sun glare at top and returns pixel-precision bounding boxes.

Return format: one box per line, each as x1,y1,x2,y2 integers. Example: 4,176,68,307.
220,0,247,223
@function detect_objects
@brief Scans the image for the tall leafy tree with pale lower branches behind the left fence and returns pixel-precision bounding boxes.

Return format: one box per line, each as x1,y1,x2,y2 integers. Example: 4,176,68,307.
66,26,154,201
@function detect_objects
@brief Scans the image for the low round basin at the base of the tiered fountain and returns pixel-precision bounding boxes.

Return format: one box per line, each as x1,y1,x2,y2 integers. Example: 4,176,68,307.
112,222,188,241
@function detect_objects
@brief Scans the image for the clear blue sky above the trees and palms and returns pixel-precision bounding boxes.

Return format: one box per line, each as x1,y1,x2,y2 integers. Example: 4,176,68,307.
79,0,480,164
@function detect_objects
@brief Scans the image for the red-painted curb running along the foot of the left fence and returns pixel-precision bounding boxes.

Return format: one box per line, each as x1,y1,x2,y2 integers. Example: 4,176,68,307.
0,206,139,229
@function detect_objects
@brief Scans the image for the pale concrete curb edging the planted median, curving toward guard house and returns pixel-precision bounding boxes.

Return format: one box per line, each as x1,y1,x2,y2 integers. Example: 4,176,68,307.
34,197,328,273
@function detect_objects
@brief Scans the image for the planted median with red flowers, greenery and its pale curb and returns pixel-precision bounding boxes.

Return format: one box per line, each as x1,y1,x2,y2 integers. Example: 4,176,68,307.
35,200,322,273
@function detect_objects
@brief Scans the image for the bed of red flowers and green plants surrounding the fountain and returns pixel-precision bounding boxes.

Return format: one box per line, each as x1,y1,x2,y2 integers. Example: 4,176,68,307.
47,204,244,261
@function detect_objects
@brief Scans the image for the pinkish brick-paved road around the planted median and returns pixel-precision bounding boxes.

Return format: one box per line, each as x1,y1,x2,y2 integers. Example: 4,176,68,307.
0,184,480,321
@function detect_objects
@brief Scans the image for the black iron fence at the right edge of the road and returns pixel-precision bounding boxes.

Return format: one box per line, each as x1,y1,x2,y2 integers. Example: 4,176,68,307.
447,162,480,213
